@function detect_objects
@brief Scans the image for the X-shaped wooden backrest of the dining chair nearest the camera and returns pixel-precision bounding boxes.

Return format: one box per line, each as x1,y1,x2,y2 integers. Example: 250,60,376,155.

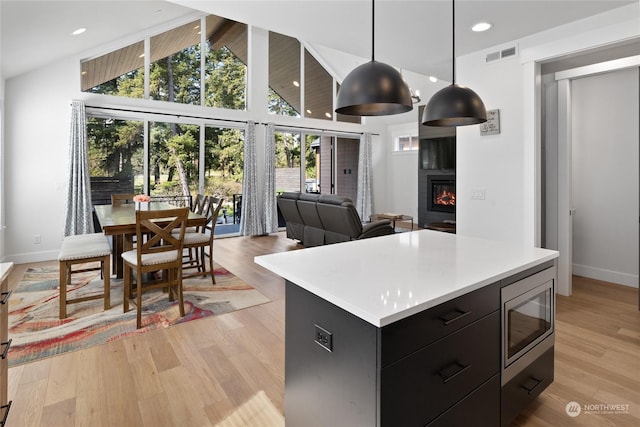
136,207,189,265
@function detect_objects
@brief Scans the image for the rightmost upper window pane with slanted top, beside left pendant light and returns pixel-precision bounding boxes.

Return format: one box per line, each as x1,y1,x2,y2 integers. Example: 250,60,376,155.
304,49,333,120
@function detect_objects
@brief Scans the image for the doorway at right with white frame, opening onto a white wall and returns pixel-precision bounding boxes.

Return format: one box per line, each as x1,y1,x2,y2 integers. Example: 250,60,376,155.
545,61,640,295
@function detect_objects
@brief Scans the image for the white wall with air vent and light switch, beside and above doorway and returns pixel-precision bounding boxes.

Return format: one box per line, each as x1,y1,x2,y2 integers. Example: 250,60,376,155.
456,3,640,249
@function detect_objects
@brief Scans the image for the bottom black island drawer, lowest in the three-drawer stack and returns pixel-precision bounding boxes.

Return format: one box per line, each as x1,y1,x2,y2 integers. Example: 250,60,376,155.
427,374,500,427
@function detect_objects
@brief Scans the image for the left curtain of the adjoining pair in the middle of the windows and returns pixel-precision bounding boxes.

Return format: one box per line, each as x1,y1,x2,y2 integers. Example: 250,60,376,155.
240,120,264,236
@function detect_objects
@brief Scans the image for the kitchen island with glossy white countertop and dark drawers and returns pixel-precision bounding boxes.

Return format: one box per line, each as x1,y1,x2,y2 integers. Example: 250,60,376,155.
255,230,557,426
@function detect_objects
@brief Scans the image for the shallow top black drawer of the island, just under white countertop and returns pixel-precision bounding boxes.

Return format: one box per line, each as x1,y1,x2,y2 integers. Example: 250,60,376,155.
381,282,500,367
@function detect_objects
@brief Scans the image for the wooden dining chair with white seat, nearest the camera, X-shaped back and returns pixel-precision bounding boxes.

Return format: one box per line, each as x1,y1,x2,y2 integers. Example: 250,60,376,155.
122,207,189,329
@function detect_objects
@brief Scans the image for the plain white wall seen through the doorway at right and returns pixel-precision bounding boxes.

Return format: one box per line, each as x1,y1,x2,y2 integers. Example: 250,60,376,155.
571,68,640,286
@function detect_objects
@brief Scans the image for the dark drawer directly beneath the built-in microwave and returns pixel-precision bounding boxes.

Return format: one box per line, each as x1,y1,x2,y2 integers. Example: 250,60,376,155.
501,347,553,426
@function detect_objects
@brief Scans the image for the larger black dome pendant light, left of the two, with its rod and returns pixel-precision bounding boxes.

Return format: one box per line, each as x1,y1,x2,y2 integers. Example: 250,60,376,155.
336,0,413,116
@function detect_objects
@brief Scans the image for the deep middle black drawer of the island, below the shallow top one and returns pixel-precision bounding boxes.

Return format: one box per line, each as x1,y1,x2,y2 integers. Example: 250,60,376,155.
380,312,500,426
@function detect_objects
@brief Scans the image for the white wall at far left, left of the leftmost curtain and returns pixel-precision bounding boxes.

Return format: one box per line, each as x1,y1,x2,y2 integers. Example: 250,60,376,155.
4,61,79,263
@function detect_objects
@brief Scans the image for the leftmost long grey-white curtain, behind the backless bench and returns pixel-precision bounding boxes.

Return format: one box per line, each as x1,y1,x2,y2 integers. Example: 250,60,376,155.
64,101,94,236
